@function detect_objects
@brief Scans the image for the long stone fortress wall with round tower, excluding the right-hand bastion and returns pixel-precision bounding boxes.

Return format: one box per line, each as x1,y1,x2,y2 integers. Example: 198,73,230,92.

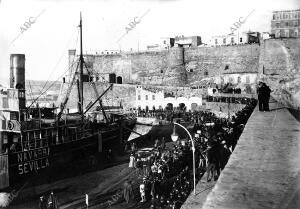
70,44,260,86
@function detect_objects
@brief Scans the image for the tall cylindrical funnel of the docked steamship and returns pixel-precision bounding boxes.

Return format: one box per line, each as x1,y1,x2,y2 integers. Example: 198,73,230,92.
10,54,25,89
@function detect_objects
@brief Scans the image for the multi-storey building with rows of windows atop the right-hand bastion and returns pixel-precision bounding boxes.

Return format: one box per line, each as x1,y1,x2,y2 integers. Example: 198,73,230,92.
271,9,300,38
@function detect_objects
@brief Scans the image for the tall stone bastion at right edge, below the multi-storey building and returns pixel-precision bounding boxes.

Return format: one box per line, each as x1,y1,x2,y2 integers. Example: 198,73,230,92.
260,38,300,109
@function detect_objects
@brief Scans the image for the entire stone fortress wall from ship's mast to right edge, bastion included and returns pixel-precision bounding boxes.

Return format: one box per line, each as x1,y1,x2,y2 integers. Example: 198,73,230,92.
58,39,300,112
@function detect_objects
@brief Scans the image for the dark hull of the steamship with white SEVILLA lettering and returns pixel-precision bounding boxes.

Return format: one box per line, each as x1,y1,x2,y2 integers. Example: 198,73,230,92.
3,117,134,191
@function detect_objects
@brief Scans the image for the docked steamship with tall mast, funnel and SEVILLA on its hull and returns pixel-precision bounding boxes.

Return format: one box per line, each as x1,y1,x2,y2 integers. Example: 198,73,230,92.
0,15,135,191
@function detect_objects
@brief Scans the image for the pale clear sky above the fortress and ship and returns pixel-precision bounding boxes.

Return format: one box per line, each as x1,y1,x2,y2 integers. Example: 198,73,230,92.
0,0,300,85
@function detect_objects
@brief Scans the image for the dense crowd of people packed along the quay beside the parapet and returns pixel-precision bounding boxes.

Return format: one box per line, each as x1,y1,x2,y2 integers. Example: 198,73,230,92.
124,99,256,209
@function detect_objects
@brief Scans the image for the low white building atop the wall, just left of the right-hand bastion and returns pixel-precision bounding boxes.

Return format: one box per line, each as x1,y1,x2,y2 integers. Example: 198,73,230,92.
210,31,260,46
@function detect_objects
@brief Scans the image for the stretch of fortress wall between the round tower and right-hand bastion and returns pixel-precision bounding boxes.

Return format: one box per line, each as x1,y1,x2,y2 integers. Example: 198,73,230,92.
185,44,260,84
